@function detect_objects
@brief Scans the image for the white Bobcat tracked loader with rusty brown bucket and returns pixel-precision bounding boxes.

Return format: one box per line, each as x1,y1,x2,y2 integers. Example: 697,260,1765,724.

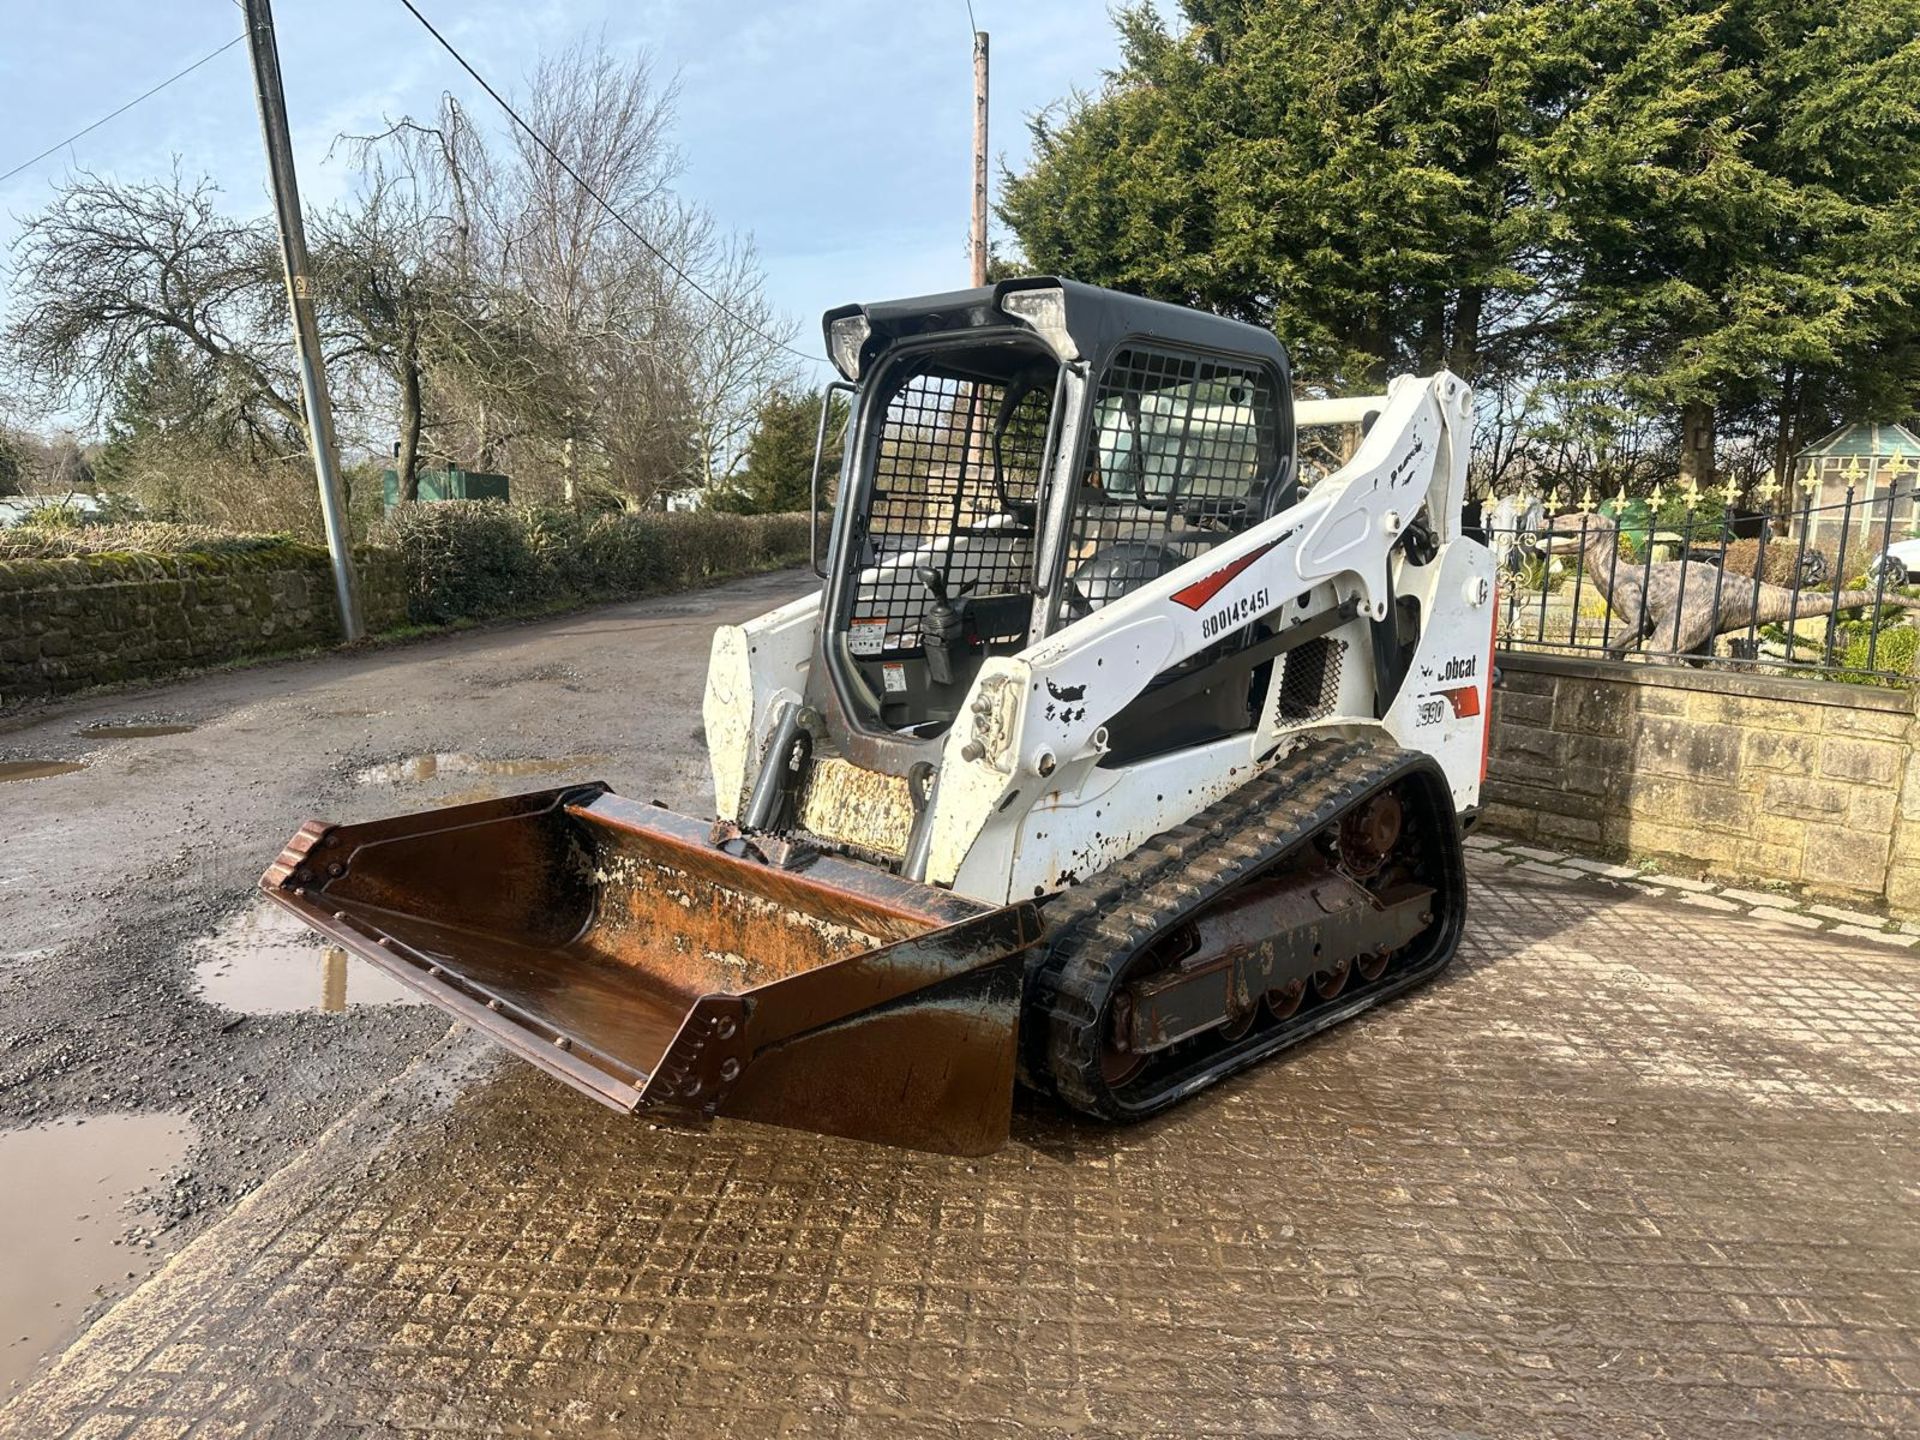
261,278,1496,1154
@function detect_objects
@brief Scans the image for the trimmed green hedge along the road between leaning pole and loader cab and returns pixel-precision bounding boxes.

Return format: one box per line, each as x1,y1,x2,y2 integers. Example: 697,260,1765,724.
372,501,806,624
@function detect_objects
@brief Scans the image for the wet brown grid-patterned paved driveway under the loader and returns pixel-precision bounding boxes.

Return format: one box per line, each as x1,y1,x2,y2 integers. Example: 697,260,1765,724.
0,840,1920,1438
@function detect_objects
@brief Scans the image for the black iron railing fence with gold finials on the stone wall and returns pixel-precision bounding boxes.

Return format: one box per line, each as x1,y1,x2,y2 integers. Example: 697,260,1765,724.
1478,490,1920,685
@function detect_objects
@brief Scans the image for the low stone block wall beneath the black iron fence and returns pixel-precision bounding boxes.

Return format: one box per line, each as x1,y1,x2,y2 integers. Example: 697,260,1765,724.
1484,653,1920,914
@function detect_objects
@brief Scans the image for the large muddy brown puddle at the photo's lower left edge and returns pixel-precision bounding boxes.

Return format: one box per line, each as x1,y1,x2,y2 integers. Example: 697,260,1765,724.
0,1114,192,1394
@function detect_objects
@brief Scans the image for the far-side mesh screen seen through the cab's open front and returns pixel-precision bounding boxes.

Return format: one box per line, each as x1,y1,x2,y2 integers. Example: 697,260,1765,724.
852,372,1054,657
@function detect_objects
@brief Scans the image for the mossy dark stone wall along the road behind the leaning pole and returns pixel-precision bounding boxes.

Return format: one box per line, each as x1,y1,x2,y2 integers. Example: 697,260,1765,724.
0,543,407,708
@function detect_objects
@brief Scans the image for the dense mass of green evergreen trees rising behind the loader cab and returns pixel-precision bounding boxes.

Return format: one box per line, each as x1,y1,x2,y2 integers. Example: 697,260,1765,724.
1000,0,1920,482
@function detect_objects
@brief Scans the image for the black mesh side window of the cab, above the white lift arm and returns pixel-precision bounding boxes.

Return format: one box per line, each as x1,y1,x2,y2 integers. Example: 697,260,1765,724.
1056,348,1279,624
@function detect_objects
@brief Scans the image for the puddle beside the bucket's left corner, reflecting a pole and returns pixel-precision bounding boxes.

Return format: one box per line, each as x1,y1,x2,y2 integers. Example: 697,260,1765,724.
192,900,424,1016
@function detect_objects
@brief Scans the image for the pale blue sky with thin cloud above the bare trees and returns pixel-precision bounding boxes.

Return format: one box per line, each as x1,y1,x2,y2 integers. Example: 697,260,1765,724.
0,0,1117,384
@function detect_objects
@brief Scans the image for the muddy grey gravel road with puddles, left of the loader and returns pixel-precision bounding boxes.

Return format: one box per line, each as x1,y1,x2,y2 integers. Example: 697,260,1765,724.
0,572,808,1390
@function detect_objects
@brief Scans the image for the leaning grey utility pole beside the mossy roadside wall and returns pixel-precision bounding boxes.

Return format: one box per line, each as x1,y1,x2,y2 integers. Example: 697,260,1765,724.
242,0,367,643
